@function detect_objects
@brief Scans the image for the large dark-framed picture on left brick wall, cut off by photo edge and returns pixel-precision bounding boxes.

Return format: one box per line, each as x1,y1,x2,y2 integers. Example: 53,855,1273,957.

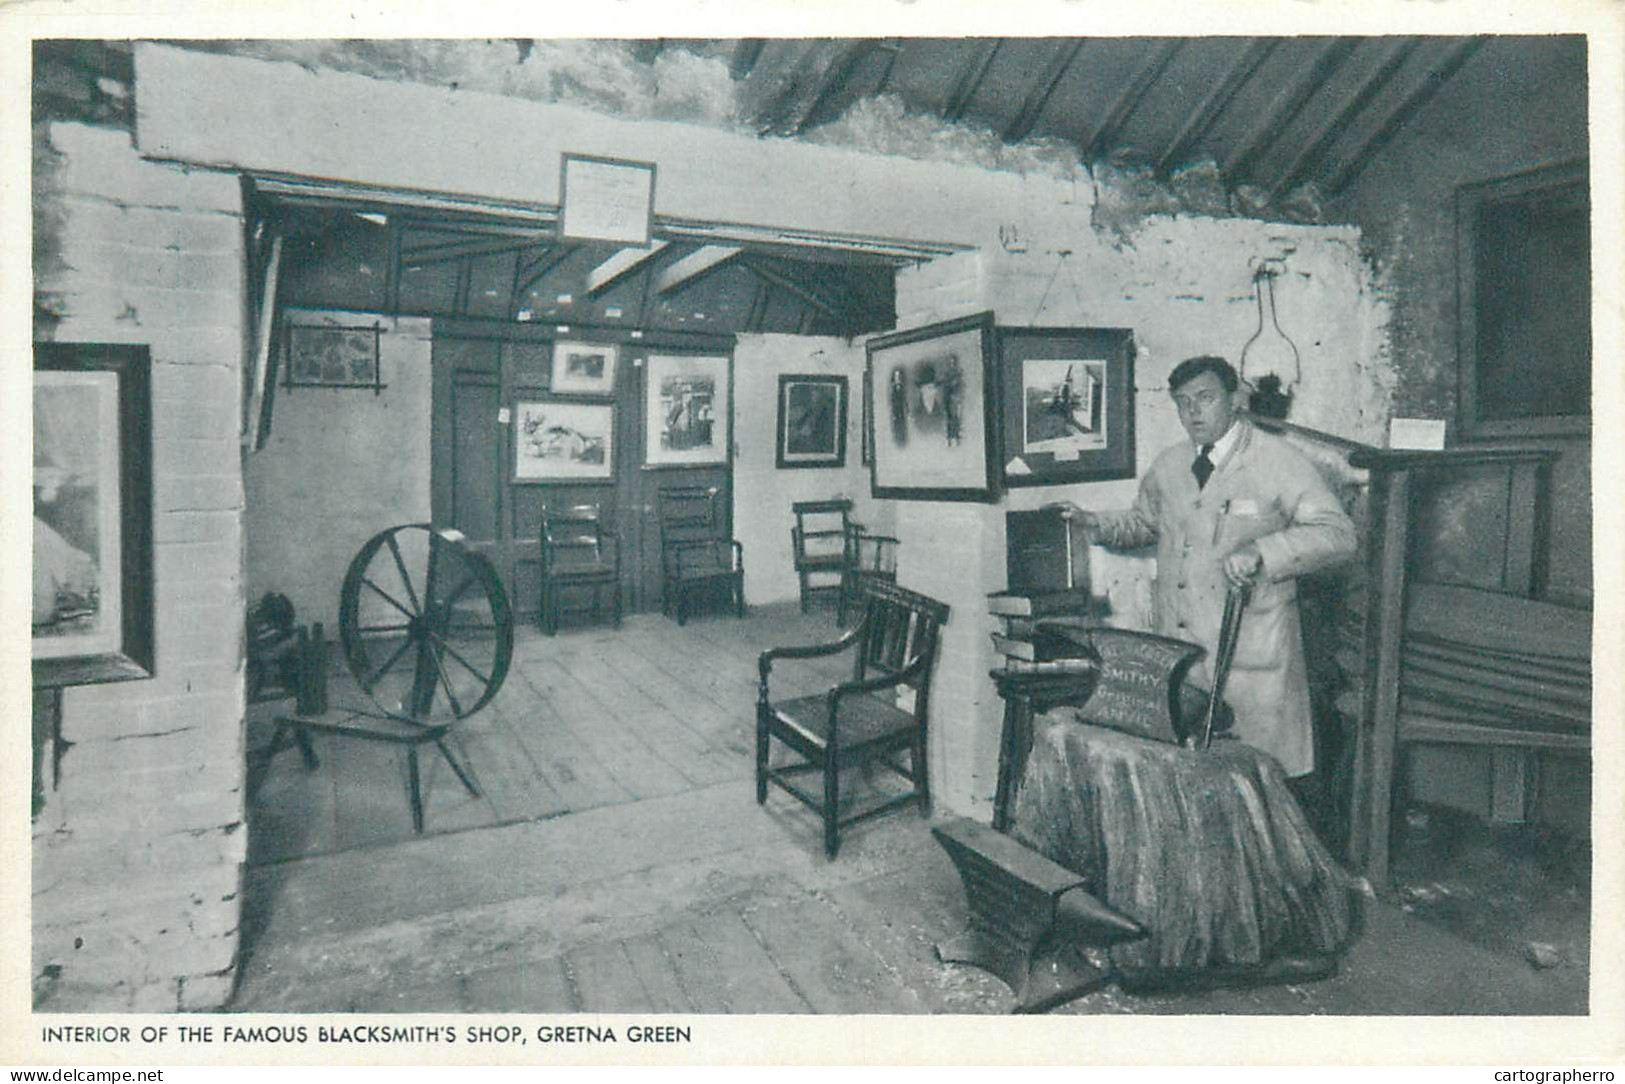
31,343,153,687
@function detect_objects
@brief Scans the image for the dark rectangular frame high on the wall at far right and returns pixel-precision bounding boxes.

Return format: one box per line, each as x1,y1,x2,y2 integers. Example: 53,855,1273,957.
1456,161,1591,440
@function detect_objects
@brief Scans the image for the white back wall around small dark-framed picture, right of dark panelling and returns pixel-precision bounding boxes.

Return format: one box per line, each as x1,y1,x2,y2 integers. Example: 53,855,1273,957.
733,335,873,606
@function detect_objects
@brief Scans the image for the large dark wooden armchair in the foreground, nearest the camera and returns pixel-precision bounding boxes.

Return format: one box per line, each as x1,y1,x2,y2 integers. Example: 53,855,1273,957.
756,580,947,858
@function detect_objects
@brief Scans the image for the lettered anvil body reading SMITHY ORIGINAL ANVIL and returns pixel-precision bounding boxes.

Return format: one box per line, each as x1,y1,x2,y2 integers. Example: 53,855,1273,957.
1077,629,1206,744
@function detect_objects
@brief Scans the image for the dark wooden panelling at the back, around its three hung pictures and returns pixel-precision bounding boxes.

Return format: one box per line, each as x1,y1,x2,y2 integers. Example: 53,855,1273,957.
431,320,733,618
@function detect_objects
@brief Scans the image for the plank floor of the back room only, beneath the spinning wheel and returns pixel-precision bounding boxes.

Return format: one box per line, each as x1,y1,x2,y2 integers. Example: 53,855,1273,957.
249,606,847,865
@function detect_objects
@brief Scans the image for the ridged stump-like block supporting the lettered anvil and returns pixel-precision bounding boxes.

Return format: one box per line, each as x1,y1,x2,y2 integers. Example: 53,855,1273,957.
1011,709,1355,972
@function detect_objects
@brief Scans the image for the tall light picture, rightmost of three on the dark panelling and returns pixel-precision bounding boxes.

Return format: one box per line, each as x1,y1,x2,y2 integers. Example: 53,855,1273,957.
644,354,733,466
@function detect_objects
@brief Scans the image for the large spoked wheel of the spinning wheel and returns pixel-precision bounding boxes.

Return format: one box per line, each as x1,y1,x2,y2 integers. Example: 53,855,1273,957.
338,523,514,726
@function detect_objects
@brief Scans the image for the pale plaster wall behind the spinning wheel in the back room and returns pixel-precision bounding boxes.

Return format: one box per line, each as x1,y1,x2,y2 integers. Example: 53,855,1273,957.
244,312,432,639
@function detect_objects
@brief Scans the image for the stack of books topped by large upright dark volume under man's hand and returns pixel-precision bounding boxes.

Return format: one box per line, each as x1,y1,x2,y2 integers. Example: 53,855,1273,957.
988,509,1095,673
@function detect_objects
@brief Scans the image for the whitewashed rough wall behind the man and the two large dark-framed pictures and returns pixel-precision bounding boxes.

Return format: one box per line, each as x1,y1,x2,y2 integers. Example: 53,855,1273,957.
886,177,1396,813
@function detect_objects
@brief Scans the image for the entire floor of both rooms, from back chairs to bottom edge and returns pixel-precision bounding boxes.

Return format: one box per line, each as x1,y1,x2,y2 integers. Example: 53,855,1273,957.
231,606,1584,1014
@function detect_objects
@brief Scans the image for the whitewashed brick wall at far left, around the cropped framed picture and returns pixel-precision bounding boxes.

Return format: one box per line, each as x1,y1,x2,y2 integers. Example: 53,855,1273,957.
33,124,247,1012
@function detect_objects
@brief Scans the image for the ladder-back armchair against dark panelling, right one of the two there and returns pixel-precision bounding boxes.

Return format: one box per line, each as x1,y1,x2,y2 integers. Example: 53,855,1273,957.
660,486,744,624
